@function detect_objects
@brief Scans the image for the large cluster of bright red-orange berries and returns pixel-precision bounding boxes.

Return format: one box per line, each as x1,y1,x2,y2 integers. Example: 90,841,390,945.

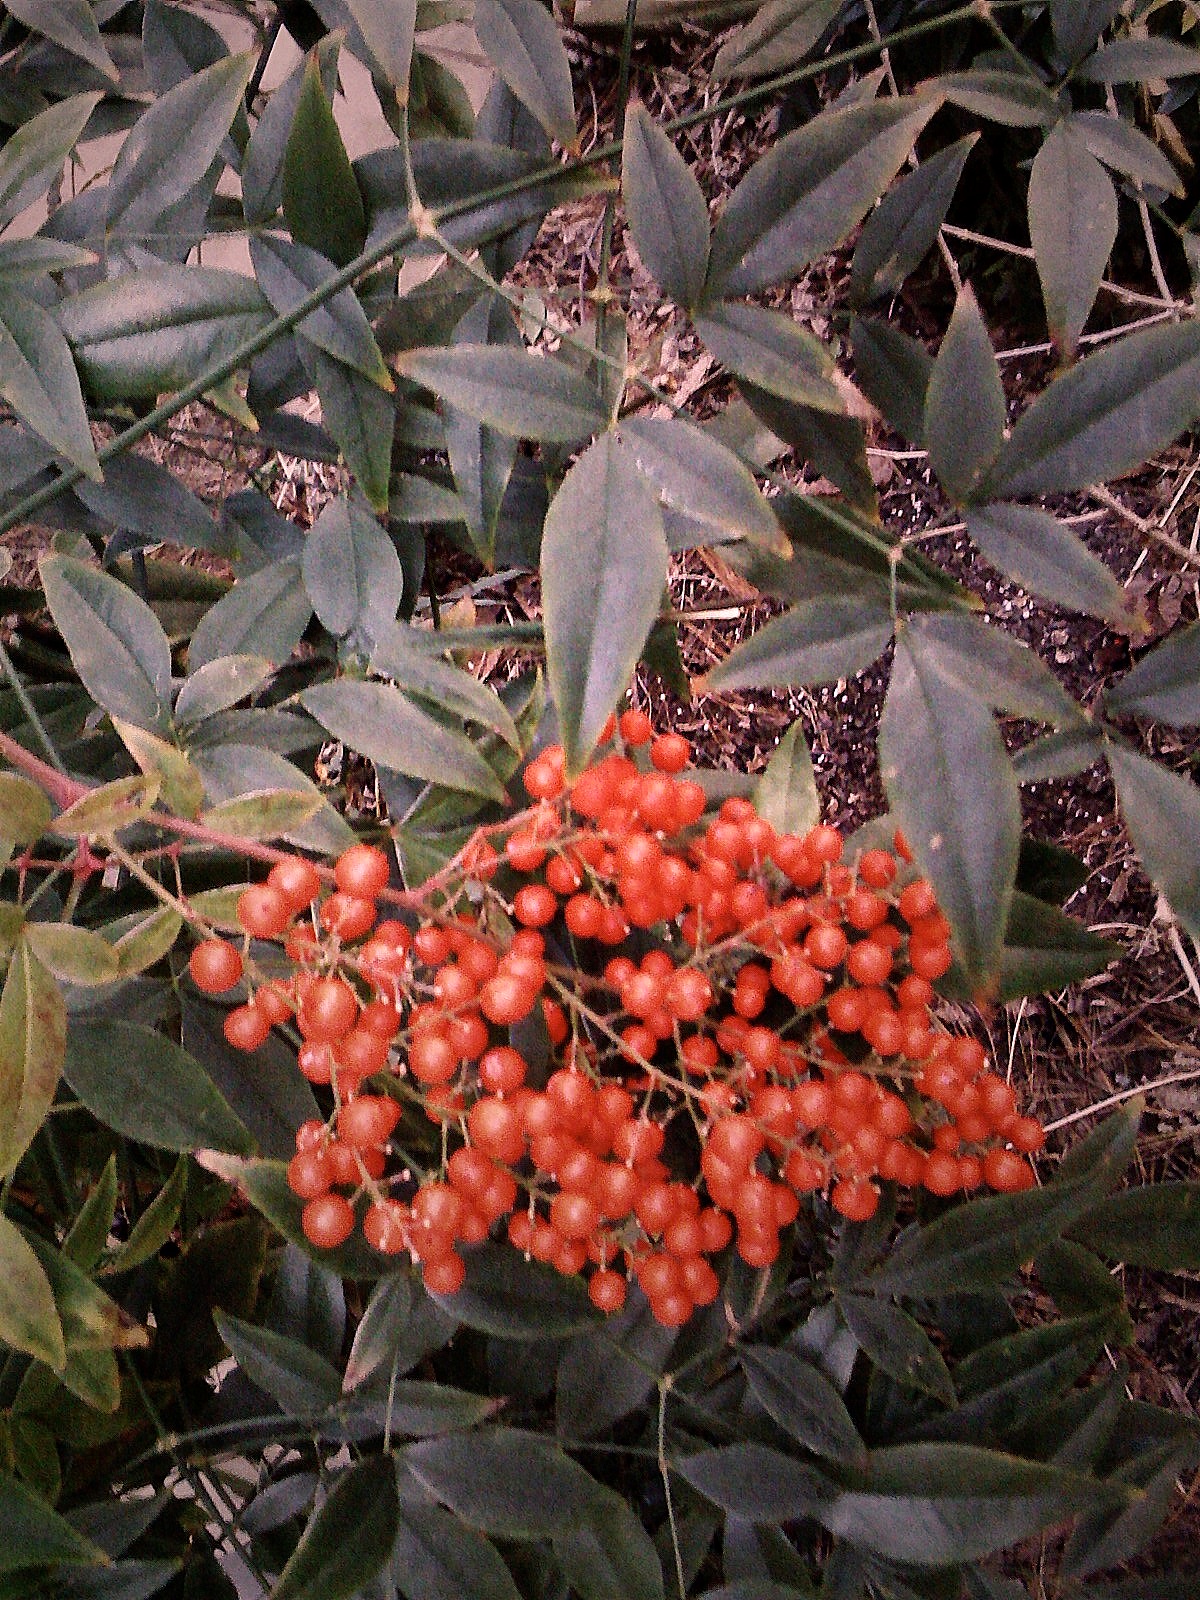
190,710,1043,1325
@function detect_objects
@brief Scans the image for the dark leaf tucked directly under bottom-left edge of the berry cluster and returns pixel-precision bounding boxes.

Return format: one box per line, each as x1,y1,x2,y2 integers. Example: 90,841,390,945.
435,1245,600,1339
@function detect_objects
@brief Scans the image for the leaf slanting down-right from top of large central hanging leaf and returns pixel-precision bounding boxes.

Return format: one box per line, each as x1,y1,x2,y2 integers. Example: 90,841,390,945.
618,416,790,554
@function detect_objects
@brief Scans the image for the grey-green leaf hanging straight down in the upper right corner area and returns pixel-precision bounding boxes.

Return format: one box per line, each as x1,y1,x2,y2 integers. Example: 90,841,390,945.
1029,123,1117,355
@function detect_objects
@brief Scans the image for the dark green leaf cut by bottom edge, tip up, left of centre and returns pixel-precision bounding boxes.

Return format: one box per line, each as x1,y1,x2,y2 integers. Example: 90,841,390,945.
272,1456,398,1600
